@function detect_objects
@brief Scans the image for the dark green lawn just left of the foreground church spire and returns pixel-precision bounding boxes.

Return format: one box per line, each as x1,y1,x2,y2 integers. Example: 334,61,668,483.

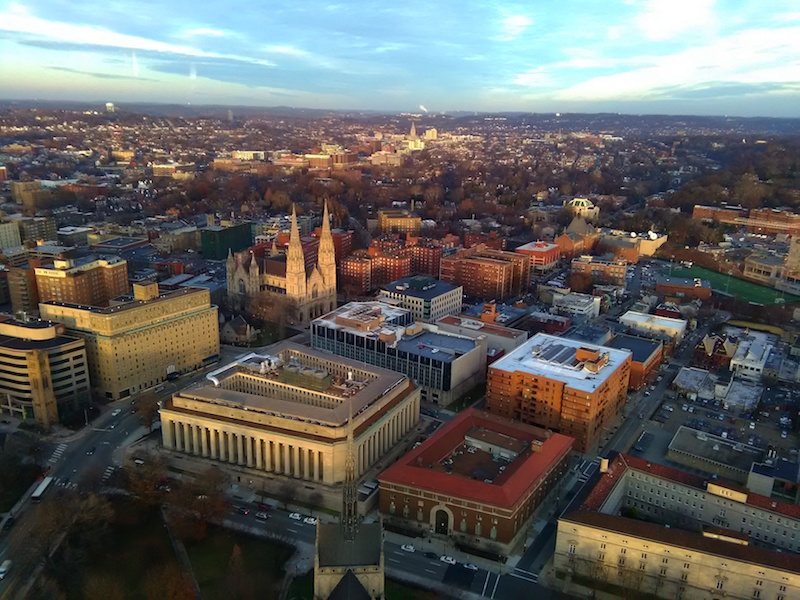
186,526,294,600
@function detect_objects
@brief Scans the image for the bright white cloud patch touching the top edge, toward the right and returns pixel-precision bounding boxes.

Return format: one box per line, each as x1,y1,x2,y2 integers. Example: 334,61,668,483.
634,0,715,41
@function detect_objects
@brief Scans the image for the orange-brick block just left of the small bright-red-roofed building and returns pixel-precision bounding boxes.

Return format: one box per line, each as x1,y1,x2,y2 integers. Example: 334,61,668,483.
440,246,531,301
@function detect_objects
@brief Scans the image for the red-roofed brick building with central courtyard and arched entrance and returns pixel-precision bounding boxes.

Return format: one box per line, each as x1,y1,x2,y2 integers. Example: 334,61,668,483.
378,409,573,554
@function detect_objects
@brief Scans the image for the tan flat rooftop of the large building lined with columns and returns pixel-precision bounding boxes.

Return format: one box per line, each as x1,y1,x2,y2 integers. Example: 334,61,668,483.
174,342,409,427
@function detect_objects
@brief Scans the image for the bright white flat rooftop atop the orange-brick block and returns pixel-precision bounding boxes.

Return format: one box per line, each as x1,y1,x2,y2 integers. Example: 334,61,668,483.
490,333,632,392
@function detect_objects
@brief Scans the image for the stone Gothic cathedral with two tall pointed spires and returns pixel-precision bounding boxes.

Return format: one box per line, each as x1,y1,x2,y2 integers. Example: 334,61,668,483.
226,204,336,327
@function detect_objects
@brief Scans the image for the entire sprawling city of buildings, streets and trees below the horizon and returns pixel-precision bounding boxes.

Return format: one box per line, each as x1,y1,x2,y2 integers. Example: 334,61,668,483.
0,86,800,600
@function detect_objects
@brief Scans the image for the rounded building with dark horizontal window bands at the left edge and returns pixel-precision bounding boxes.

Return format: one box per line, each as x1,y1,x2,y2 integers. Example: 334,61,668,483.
0,317,90,431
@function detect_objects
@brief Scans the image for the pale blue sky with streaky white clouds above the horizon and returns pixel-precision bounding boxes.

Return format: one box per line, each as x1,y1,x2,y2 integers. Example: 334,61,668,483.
0,0,800,117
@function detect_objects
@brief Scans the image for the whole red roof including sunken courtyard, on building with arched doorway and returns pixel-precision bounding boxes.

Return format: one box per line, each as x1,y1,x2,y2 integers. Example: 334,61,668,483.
379,409,574,507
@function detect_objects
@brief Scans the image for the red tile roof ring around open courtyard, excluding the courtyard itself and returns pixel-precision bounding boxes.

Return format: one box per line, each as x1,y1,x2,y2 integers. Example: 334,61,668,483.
378,409,575,508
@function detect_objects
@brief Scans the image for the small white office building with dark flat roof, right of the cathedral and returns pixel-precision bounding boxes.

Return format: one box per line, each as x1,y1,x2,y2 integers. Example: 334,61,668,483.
378,276,464,323
